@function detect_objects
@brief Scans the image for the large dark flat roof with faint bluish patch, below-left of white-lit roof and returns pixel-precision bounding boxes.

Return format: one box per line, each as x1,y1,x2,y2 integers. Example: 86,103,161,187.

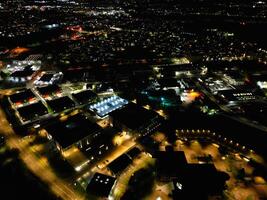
45,113,102,148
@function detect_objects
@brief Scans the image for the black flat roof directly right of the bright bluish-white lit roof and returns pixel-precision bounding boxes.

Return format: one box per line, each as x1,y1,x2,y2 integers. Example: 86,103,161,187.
110,103,157,129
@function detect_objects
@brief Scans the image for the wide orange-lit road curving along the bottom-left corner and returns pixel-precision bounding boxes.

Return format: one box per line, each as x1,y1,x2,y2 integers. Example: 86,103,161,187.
0,107,83,200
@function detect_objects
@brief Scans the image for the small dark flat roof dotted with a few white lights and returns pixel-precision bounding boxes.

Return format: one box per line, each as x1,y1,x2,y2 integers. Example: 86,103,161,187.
86,173,116,197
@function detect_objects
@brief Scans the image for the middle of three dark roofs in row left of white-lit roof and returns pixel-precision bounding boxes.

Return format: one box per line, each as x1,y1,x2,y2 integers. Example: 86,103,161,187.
47,96,75,112
